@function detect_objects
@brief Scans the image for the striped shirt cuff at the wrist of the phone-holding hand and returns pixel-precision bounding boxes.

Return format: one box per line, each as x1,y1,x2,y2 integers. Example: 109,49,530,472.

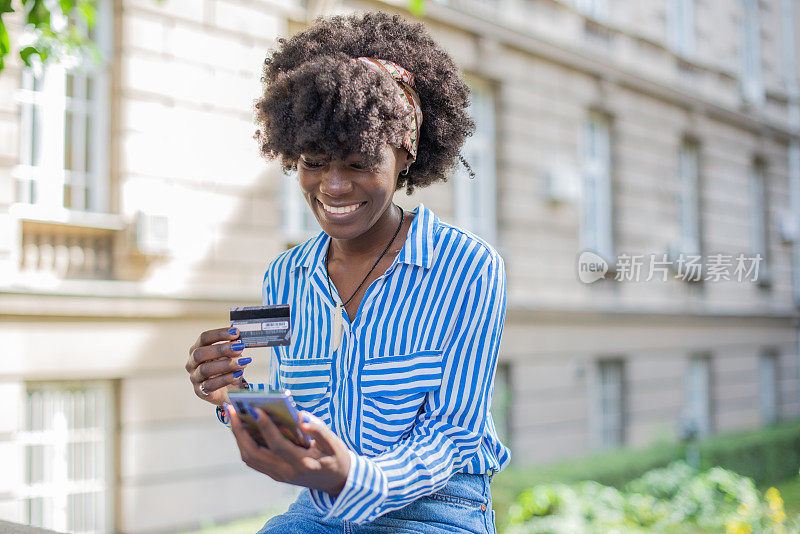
310,451,389,523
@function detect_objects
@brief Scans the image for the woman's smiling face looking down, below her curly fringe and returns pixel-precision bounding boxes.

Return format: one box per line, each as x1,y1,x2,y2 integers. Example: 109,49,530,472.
297,144,410,239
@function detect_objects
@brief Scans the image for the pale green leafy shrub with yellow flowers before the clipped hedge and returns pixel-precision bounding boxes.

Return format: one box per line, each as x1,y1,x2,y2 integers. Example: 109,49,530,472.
506,462,800,534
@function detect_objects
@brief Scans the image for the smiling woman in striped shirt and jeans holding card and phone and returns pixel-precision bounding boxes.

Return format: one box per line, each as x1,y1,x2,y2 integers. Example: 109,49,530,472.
186,13,510,534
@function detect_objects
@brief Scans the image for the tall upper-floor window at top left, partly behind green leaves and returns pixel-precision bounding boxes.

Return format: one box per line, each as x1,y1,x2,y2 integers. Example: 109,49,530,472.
13,1,113,213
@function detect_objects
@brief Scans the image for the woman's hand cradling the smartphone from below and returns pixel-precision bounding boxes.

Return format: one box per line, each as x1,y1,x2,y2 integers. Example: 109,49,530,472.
227,404,350,497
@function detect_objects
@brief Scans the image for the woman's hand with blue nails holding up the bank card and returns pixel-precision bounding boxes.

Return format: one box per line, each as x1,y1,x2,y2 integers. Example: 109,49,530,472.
186,328,252,406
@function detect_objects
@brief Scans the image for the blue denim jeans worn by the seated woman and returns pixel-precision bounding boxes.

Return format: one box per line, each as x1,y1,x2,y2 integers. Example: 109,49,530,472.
258,473,495,534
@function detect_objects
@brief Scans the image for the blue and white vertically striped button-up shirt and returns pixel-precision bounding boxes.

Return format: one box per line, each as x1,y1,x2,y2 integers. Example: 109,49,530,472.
251,204,510,523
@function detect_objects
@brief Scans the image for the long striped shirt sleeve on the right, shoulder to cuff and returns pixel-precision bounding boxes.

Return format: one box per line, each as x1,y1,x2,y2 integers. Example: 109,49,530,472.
311,253,506,523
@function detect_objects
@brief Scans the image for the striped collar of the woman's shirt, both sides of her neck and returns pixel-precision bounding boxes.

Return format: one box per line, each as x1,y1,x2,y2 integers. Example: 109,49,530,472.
291,204,439,270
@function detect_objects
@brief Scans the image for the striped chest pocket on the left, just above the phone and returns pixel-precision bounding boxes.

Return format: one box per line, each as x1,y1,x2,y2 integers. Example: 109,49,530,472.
279,358,331,422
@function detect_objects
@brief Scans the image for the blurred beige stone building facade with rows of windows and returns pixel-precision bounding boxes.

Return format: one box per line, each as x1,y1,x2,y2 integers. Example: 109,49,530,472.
0,0,800,532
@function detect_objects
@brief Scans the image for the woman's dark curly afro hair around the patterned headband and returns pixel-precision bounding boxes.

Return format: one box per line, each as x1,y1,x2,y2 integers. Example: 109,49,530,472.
255,12,475,195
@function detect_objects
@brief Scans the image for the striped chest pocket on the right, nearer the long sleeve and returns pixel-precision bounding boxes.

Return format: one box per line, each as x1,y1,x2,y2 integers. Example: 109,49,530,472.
361,350,442,454
